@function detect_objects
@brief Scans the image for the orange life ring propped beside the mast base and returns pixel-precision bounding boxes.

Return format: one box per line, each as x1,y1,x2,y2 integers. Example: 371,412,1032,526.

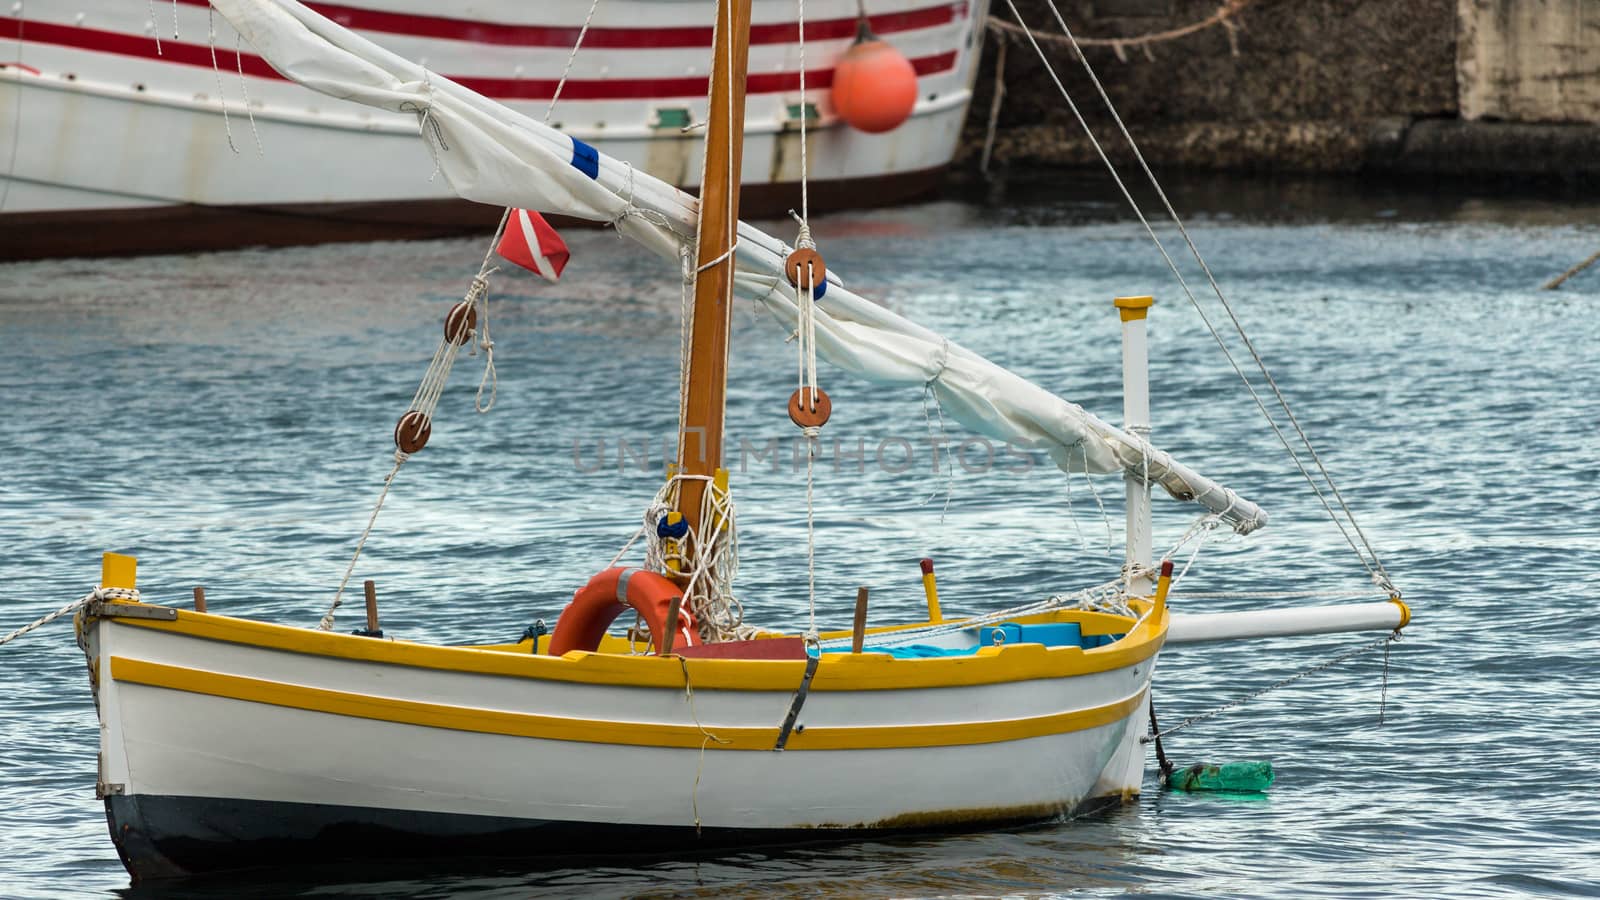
550,565,698,657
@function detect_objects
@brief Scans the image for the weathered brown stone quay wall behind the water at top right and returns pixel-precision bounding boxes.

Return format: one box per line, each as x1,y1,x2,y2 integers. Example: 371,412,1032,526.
958,0,1600,175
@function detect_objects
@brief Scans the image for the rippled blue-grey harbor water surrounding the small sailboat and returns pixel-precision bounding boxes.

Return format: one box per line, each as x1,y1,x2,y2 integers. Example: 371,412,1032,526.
0,178,1600,898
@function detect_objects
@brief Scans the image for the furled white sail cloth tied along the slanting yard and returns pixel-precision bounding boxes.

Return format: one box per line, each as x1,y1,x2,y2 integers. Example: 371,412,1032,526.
211,0,1267,533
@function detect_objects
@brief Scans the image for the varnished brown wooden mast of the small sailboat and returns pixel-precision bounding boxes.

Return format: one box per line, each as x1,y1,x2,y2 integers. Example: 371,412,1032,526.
678,0,750,535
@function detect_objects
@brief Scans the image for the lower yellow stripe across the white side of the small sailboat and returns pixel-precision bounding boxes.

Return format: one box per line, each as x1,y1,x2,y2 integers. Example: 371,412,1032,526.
110,657,1144,751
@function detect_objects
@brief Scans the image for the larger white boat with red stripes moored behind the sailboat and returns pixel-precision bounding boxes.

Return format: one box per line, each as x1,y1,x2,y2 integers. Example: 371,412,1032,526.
0,0,984,259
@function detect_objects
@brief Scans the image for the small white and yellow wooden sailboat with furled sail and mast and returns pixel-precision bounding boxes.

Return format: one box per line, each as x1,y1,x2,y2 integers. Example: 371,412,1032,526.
77,0,1406,878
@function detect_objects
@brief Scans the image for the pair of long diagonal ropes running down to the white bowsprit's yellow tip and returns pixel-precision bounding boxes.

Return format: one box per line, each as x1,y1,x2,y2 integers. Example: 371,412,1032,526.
1006,0,1400,596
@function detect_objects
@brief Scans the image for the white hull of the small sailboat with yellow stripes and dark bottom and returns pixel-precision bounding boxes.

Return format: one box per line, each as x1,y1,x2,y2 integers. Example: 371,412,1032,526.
85,595,1160,874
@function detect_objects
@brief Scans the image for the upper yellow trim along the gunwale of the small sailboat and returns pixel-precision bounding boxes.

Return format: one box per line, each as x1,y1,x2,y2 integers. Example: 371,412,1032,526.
107,604,1168,692
